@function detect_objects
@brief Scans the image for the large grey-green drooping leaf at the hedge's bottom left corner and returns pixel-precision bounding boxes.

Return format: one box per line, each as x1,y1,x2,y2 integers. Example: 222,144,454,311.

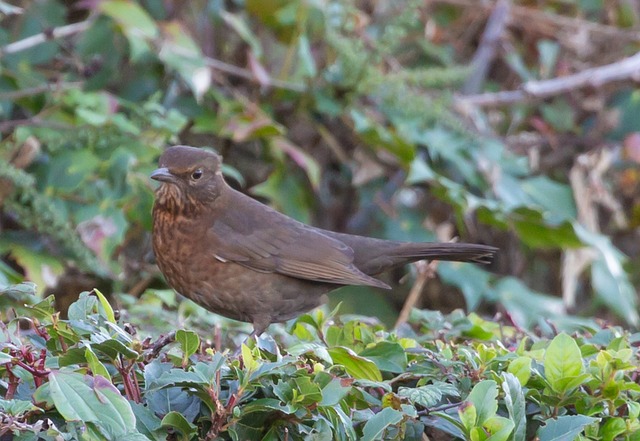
49,371,136,439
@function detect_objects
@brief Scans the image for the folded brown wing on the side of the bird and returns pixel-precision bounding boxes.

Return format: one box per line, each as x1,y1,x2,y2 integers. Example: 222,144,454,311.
206,197,389,288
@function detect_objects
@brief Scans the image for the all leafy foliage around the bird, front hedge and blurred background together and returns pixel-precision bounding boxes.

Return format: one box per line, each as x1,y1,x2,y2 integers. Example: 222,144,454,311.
0,0,640,440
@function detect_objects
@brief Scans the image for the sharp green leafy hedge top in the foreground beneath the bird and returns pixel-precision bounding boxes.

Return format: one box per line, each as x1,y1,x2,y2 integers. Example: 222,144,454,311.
0,285,640,440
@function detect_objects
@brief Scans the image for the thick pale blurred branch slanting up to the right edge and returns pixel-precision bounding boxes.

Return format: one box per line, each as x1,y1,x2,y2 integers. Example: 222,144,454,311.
455,52,640,109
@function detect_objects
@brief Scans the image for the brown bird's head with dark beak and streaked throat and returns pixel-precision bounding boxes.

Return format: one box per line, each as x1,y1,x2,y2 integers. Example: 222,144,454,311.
151,145,226,211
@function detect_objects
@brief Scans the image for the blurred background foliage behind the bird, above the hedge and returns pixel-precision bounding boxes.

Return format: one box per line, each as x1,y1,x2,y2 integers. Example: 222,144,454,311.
0,0,640,329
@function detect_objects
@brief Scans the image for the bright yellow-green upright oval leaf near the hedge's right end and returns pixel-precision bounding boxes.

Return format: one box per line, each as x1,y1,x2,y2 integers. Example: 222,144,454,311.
544,333,583,394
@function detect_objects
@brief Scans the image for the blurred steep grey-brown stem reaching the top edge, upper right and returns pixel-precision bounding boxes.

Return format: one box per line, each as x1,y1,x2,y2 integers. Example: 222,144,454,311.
462,0,511,95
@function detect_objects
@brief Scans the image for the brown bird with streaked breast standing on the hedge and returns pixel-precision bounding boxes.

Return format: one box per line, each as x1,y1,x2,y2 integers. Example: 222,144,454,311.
151,146,497,335
